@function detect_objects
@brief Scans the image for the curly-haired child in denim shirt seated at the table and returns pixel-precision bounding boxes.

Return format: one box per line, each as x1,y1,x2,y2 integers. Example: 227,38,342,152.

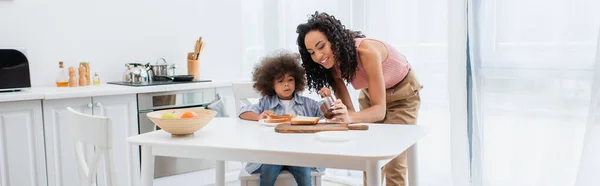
239,52,322,186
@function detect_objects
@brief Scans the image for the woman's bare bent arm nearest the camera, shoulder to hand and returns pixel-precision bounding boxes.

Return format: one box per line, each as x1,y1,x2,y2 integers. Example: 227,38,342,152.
335,40,388,123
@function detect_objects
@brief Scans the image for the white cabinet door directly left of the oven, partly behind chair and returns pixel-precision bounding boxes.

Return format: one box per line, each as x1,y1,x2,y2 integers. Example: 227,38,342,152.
92,94,140,186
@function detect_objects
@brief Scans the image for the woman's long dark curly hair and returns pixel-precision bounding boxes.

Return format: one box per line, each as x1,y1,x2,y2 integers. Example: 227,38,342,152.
296,11,365,91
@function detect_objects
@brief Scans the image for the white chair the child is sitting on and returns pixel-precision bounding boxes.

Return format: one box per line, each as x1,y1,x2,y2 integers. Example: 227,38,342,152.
232,82,323,186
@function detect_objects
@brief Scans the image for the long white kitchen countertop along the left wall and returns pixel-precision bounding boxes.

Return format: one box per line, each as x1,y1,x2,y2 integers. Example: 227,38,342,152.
0,81,231,102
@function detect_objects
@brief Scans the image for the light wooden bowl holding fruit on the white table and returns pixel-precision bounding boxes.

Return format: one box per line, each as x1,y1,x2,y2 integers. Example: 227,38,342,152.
146,108,217,136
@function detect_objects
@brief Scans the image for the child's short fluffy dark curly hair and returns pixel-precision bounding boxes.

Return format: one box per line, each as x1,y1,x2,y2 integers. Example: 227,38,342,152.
252,51,306,96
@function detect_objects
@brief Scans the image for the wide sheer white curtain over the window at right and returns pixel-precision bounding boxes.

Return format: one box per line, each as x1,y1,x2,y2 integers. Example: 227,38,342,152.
469,0,600,186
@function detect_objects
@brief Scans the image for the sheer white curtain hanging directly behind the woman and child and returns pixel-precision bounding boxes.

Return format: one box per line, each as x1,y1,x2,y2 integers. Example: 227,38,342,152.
242,0,468,186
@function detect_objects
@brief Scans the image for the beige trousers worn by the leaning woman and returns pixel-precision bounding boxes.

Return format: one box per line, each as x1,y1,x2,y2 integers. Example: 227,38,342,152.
358,70,423,186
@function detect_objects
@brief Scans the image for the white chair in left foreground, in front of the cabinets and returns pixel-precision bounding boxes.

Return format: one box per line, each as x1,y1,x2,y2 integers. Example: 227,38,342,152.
64,107,116,186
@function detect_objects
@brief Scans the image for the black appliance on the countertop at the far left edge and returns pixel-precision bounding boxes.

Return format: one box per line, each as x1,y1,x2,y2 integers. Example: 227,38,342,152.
0,49,31,92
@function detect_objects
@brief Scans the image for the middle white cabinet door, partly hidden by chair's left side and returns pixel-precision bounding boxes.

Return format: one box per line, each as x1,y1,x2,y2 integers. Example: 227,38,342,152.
43,97,92,186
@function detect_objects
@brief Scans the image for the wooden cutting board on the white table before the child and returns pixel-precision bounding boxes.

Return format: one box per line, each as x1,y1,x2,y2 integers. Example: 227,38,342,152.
275,123,369,133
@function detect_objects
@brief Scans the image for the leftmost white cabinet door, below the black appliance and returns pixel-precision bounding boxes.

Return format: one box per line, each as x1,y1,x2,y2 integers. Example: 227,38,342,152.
0,100,46,186
